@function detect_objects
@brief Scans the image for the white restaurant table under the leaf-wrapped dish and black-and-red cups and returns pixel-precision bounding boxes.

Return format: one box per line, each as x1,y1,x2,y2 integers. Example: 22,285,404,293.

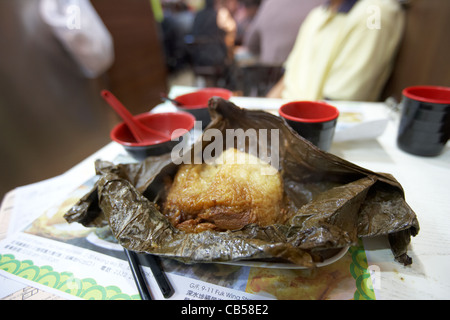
0,87,450,299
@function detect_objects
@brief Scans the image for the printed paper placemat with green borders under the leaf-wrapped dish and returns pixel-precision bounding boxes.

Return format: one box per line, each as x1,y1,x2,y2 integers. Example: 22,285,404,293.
0,172,375,300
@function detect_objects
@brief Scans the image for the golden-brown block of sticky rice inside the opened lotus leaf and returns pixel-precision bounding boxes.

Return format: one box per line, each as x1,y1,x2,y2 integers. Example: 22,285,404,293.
163,149,284,232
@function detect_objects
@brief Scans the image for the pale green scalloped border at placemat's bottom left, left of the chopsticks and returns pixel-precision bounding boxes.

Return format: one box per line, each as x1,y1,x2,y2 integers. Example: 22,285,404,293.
0,254,140,300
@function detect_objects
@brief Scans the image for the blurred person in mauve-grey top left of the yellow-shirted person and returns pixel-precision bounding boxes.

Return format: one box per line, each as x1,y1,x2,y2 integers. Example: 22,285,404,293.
242,0,326,65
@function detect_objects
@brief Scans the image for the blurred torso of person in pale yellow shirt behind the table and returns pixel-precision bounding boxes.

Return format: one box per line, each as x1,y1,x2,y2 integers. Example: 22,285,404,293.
267,0,405,101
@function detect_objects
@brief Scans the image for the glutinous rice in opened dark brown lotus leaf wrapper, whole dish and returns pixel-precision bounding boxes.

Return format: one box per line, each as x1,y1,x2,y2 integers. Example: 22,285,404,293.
65,98,419,268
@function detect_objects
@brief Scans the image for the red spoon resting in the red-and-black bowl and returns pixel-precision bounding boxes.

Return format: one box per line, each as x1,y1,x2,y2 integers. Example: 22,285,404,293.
101,90,170,144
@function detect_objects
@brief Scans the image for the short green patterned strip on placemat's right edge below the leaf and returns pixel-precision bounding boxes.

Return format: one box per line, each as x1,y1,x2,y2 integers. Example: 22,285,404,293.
348,242,375,300
